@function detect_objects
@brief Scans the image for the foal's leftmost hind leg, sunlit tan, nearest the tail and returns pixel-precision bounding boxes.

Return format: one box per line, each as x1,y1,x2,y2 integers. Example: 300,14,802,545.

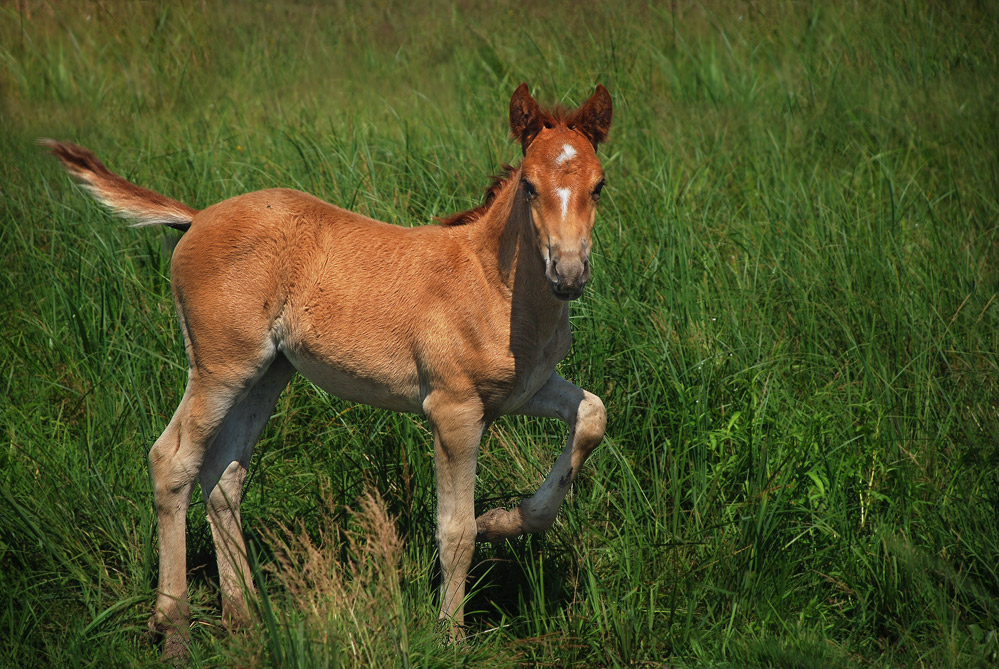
149,373,250,657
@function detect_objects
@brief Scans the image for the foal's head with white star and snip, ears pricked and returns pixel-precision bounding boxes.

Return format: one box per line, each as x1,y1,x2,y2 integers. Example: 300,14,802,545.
510,84,611,300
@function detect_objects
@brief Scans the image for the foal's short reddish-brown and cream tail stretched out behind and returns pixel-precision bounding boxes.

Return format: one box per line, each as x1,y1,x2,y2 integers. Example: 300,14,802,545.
38,139,198,230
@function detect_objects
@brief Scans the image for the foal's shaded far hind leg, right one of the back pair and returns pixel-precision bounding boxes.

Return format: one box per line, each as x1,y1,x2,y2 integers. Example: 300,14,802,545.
199,355,295,629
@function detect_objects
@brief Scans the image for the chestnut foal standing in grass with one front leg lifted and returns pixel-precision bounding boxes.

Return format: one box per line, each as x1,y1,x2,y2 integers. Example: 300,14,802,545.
42,84,611,656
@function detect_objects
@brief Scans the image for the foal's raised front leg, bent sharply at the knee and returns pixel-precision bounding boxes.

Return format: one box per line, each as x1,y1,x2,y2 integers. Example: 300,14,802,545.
475,373,607,541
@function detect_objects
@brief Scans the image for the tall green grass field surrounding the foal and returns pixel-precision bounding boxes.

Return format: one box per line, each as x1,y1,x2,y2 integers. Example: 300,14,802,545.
0,0,999,667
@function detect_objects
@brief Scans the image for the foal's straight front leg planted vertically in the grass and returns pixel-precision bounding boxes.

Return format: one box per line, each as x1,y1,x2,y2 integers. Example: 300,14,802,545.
423,392,485,639
